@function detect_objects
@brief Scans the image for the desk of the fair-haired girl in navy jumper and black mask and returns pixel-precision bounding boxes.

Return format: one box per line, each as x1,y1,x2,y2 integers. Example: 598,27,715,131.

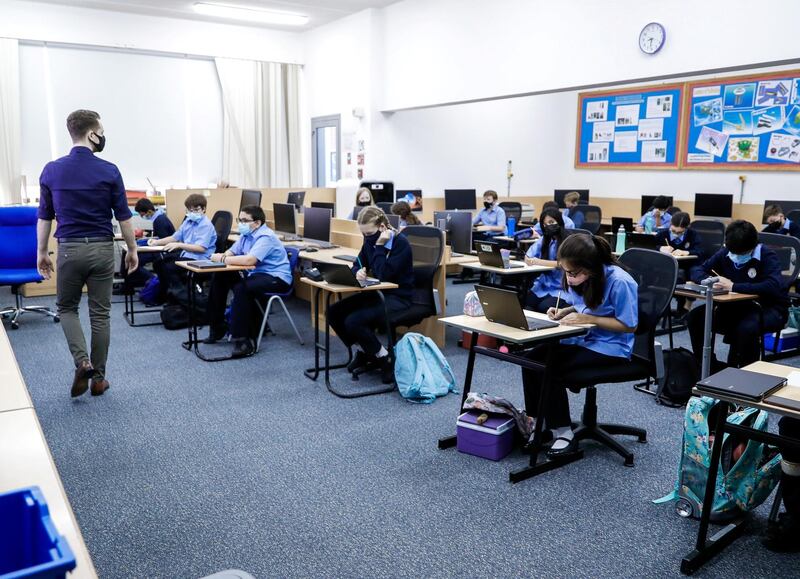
300,277,399,398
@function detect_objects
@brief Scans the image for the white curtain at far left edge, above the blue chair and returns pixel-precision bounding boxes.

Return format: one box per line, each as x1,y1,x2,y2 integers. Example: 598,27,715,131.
0,38,22,205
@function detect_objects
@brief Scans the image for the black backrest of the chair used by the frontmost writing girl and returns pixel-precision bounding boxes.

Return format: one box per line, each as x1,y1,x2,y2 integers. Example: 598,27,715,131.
619,248,678,364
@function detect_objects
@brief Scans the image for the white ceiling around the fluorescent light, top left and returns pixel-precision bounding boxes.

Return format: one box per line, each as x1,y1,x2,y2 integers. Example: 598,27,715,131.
25,0,398,30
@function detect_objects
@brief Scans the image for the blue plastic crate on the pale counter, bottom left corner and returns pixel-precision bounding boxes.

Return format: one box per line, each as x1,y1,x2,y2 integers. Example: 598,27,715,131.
0,487,75,579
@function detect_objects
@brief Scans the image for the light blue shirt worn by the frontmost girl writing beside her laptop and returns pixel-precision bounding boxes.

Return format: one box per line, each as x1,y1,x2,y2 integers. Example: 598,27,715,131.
561,265,639,360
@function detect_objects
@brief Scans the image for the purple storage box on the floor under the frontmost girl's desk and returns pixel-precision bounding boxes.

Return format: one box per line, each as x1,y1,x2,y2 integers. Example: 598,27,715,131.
456,410,515,460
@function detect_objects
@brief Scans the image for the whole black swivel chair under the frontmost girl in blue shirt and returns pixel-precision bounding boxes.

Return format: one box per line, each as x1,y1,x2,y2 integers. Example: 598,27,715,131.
560,248,678,466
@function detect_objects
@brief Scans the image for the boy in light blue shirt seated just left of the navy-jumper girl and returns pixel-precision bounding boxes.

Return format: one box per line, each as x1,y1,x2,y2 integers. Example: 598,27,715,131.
203,205,292,358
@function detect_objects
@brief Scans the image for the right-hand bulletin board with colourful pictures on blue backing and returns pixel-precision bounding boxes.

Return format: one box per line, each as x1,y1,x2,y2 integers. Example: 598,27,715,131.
681,70,800,171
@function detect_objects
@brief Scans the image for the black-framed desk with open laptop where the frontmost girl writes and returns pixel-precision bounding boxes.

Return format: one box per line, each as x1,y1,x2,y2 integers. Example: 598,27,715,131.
432,310,593,483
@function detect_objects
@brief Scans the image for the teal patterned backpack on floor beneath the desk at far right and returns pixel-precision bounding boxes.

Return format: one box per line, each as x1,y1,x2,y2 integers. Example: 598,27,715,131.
653,396,781,521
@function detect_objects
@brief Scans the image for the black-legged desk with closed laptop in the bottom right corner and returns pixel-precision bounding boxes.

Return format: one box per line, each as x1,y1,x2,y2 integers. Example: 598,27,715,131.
681,362,800,574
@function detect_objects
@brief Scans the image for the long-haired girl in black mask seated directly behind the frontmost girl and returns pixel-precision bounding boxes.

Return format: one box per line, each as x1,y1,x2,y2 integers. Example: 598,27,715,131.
525,207,569,313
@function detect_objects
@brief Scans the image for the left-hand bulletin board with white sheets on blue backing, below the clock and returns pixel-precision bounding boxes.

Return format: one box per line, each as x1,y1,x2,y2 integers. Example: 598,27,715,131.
575,84,684,169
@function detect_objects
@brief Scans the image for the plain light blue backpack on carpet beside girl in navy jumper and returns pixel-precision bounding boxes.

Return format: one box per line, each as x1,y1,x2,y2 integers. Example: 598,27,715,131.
394,332,458,404
